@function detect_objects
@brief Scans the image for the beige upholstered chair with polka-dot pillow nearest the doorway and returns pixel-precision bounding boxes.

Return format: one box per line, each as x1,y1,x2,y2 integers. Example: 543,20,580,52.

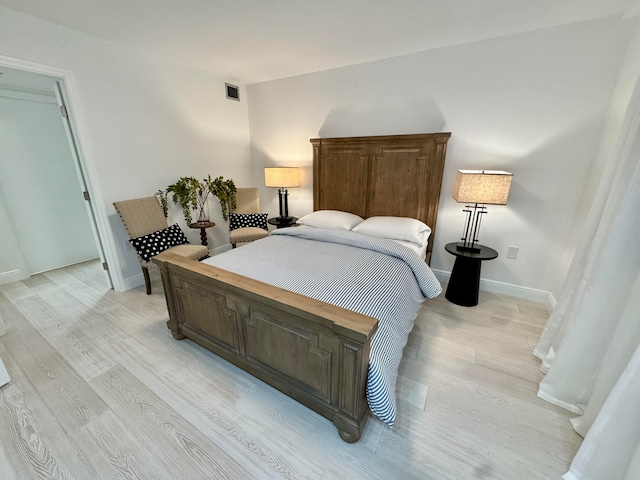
113,197,209,295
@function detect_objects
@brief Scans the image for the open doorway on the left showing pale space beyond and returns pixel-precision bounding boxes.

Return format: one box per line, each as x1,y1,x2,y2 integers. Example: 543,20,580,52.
0,66,112,287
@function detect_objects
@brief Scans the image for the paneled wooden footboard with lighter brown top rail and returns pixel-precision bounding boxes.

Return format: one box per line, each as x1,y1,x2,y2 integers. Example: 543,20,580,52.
153,253,378,442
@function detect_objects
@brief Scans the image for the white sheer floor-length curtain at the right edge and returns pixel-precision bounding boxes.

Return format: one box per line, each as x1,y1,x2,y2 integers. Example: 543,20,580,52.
534,67,640,480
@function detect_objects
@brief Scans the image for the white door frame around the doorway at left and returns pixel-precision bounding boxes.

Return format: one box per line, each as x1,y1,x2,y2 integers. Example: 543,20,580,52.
0,55,126,291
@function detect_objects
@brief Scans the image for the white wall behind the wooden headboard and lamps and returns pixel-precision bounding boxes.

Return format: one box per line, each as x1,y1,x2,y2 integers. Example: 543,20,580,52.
247,18,629,294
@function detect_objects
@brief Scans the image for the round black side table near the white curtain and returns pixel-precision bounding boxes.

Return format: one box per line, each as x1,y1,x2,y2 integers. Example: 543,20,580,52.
444,242,498,307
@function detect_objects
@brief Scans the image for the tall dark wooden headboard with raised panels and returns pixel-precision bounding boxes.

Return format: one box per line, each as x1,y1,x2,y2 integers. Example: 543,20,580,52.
311,133,451,263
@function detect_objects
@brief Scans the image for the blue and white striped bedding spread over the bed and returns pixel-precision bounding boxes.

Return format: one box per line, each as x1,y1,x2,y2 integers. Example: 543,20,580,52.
204,227,442,425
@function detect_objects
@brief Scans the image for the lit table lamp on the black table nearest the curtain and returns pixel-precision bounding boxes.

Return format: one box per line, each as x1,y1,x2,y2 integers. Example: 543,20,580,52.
453,170,513,253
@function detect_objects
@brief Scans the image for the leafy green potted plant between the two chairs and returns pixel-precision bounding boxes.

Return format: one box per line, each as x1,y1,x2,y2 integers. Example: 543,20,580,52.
156,175,236,225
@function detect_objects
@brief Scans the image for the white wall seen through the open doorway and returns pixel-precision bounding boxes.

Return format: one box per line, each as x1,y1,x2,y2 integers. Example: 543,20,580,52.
0,89,98,282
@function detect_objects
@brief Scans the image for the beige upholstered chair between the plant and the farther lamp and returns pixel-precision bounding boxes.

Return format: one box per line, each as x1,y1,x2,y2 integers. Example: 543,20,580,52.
229,187,269,248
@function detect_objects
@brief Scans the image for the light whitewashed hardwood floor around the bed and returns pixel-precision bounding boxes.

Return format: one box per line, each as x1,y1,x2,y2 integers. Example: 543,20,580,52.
0,262,581,480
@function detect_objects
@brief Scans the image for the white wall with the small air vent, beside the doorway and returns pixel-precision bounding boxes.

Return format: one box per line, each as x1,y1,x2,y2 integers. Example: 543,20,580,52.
0,7,251,288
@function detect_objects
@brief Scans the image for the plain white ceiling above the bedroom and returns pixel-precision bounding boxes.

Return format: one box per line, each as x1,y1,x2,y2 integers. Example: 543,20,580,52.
0,0,638,84
